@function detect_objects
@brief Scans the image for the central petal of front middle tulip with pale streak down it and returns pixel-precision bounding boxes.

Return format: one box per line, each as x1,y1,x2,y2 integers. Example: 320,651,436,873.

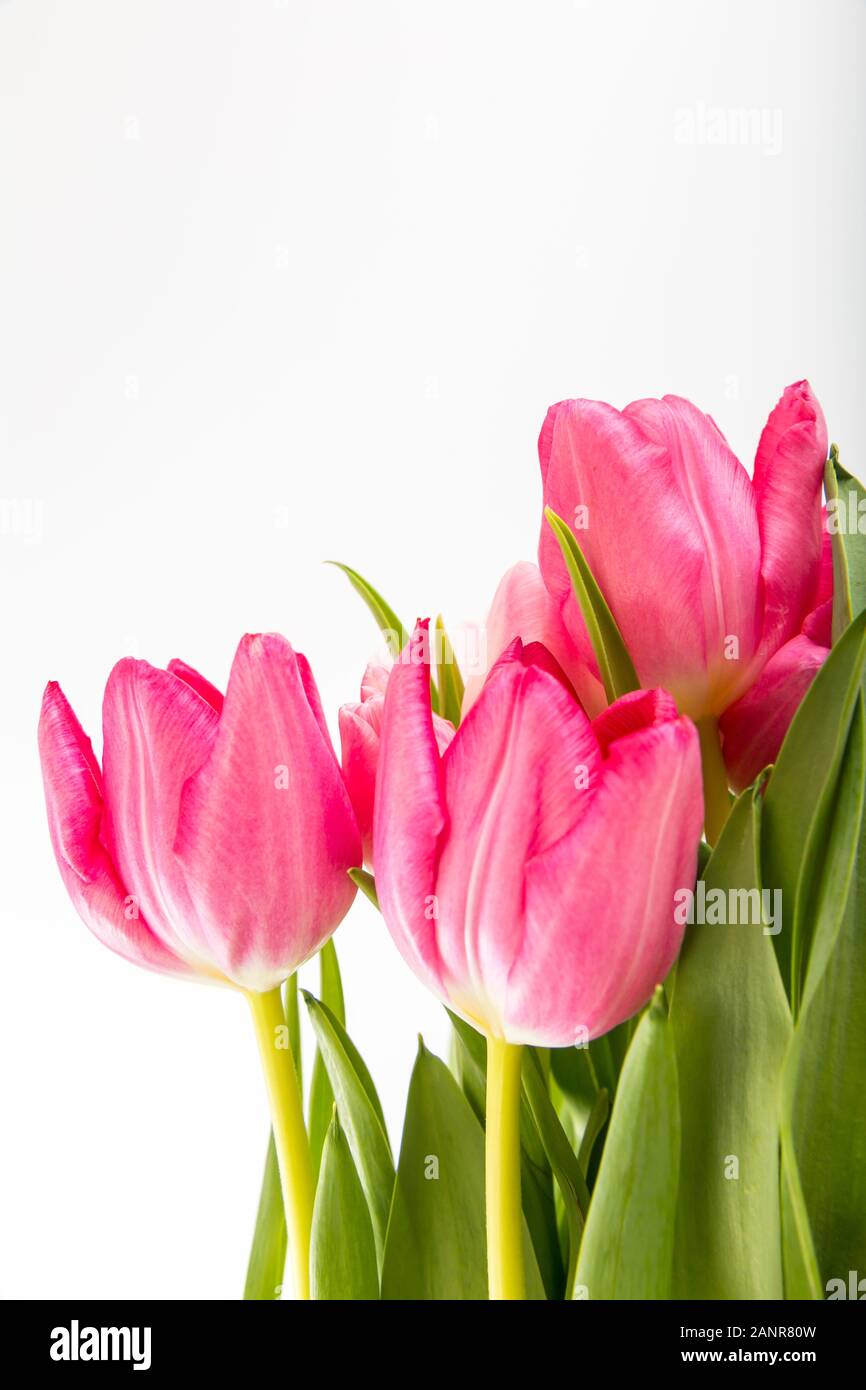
436,642,601,1036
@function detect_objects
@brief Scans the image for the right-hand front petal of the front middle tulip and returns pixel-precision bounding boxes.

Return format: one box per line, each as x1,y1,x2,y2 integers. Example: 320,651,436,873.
505,706,703,1047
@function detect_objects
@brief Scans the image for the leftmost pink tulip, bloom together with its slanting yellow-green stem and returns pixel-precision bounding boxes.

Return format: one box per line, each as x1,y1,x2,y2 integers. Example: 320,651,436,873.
39,634,360,1297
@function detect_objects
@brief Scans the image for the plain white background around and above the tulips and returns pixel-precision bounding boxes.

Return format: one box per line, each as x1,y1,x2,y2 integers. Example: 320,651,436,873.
0,0,866,1298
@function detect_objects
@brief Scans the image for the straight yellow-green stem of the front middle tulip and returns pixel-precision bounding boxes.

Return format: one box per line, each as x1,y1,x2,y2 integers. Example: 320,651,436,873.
485,1038,525,1298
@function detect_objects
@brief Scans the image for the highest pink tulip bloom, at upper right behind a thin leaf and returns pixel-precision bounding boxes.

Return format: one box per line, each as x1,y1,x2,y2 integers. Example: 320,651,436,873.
538,381,833,830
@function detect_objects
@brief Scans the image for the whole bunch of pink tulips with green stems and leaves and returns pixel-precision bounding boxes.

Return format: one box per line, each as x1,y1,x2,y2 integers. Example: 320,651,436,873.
39,382,866,1300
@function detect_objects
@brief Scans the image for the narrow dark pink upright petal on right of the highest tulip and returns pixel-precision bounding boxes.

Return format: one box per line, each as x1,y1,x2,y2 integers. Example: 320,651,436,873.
753,381,827,655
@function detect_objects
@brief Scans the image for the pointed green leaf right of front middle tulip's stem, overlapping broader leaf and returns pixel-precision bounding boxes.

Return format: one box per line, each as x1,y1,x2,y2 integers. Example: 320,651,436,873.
575,988,680,1300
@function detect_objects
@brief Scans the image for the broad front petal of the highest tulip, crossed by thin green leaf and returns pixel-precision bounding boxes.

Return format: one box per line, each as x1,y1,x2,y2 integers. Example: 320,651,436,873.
538,396,760,714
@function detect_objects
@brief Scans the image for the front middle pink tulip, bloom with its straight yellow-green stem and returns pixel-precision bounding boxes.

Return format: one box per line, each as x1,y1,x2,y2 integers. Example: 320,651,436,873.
374,624,703,1298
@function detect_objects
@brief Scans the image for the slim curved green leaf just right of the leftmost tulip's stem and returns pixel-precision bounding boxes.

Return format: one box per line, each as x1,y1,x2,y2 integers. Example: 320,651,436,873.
303,990,393,1266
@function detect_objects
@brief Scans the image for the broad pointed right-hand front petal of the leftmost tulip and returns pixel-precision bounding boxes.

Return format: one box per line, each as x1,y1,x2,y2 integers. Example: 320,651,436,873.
174,634,361,990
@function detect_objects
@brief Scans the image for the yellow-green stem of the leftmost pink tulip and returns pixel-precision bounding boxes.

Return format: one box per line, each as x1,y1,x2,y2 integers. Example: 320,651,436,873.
246,990,316,1298
